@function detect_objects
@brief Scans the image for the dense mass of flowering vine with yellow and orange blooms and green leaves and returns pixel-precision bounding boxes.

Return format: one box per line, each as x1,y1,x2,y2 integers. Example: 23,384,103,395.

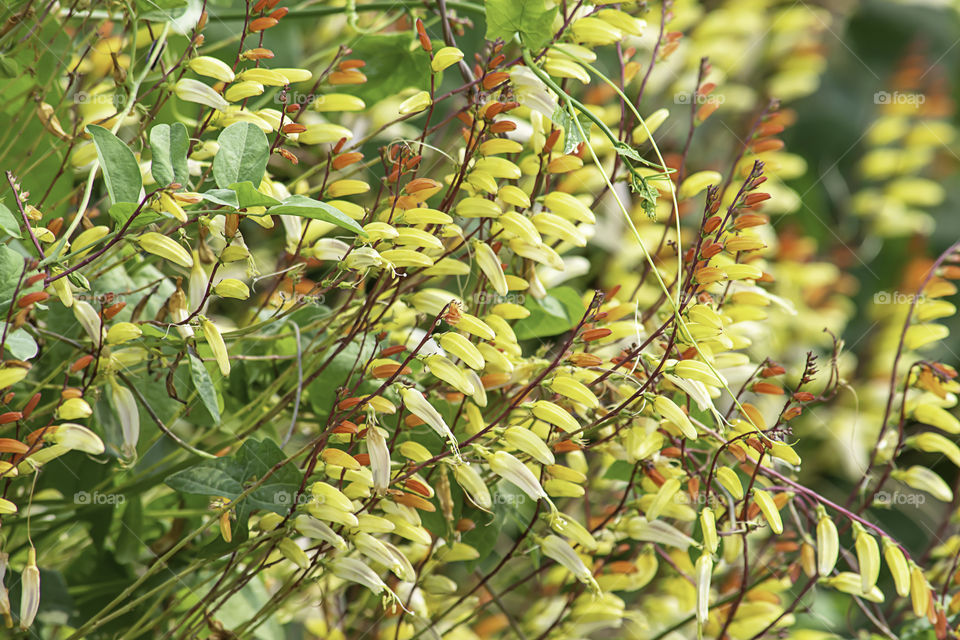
0,0,960,640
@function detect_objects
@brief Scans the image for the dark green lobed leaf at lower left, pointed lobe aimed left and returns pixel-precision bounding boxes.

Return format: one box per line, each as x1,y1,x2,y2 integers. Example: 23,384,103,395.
166,438,301,514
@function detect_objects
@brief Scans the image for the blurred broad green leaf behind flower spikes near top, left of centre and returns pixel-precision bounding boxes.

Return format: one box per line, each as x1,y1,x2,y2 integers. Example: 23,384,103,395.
338,33,430,104
